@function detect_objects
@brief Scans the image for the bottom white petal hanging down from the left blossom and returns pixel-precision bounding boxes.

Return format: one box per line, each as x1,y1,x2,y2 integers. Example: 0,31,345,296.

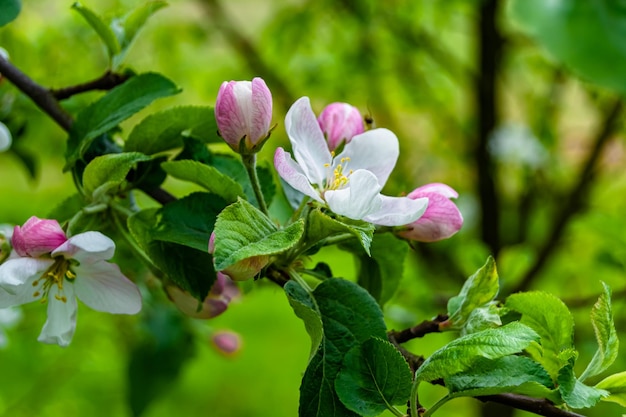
37,283,76,347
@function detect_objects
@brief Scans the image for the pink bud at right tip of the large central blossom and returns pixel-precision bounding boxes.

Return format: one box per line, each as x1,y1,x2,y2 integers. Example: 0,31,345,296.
398,183,463,242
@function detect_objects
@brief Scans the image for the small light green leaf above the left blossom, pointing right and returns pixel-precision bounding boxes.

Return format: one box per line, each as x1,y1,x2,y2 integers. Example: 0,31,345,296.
83,152,150,195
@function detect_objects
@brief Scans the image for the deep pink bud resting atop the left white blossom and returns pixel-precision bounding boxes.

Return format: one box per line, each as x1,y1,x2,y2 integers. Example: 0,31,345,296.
11,216,67,258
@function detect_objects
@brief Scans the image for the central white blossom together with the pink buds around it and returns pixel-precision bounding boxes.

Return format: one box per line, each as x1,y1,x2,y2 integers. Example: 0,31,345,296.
214,78,463,280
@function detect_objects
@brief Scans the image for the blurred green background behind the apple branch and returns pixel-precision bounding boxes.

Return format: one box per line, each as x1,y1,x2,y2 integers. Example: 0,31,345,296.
0,0,626,417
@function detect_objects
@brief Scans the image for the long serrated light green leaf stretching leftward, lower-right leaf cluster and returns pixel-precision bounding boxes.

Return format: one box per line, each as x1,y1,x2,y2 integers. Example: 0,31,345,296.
415,322,539,381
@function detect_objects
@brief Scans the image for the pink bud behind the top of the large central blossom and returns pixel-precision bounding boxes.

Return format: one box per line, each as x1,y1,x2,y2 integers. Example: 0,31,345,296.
317,103,365,151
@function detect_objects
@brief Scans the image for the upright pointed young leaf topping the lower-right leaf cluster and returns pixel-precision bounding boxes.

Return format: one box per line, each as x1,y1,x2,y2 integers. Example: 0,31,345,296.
441,256,499,329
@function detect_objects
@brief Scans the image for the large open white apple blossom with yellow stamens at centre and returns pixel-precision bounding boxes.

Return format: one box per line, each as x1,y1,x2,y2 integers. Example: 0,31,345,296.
274,97,428,226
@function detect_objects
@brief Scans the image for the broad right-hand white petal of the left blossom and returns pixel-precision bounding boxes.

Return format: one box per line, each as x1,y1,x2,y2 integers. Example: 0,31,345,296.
74,261,141,314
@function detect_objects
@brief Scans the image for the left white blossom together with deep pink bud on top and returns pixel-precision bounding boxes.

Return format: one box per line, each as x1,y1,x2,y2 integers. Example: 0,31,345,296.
0,218,141,346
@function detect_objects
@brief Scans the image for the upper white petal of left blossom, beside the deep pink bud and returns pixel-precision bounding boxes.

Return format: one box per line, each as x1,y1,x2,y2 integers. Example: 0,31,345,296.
52,232,115,263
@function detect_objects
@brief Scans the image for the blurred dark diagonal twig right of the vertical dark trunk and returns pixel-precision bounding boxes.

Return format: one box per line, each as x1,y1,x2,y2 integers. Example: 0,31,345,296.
512,98,623,292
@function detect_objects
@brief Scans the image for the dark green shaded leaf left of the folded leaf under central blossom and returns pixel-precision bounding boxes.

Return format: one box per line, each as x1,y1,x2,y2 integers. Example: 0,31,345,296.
151,193,228,252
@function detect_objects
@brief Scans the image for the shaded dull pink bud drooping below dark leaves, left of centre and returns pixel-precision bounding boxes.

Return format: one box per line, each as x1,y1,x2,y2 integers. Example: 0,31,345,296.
165,272,239,319
